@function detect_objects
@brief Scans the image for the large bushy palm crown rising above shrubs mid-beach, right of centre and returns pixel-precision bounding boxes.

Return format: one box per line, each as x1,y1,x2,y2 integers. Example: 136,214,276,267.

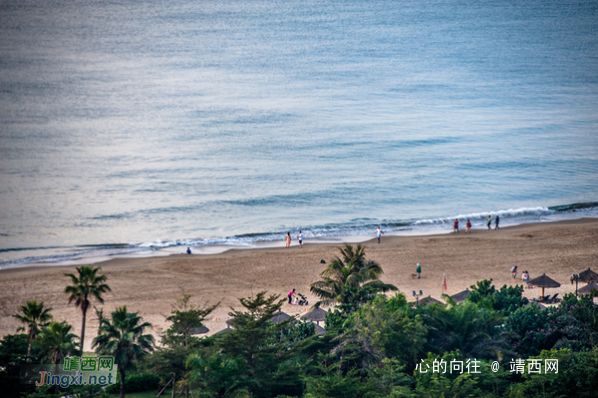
310,244,398,305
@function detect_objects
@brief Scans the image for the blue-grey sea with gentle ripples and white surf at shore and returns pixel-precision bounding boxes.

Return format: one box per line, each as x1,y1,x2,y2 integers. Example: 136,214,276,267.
0,0,598,268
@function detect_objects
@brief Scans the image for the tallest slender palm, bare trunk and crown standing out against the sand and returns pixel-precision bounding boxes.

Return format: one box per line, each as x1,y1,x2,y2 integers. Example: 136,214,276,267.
64,265,110,355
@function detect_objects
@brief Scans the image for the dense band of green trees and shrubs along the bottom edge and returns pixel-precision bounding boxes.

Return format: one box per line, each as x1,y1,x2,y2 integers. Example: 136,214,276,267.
0,246,598,398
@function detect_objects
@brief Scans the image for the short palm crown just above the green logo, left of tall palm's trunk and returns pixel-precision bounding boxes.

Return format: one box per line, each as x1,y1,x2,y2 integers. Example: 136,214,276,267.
39,321,78,365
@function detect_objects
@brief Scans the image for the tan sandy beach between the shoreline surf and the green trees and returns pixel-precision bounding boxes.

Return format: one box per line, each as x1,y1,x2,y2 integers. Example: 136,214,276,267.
0,219,598,349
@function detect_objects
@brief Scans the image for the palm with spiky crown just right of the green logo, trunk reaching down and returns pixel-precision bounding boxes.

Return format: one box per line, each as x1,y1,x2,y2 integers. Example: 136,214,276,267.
93,306,154,398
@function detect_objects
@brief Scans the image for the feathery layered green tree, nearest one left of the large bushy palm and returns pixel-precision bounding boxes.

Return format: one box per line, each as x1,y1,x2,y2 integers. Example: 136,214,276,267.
189,292,301,397
